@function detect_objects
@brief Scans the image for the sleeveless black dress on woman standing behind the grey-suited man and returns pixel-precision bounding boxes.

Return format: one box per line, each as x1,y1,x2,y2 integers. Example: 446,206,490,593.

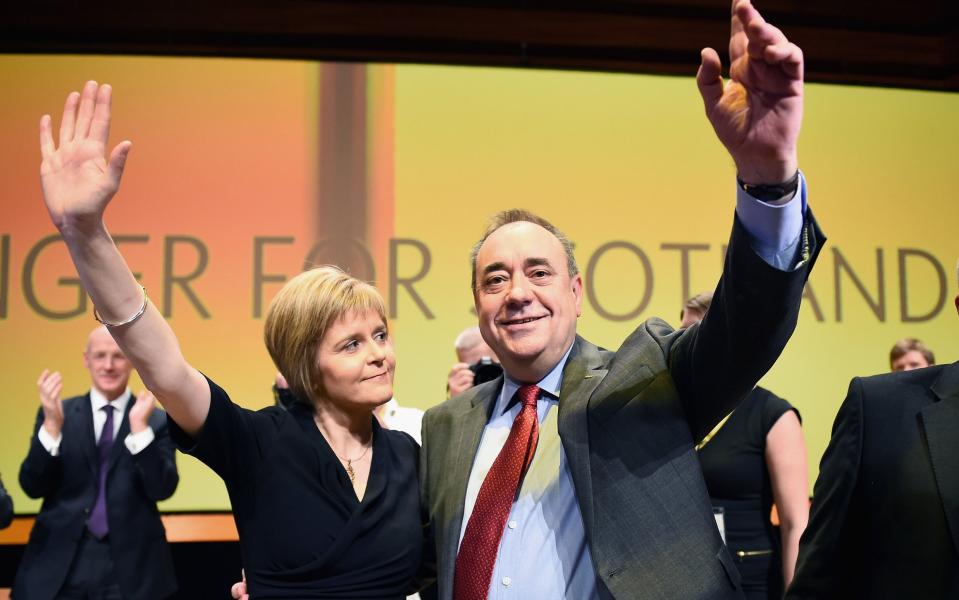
699,387,799,600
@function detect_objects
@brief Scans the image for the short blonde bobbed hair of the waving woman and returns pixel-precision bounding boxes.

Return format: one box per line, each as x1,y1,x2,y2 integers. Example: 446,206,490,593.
263,265,386,404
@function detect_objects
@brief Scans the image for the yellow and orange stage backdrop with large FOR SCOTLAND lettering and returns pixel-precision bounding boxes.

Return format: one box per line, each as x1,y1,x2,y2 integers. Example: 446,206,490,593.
0,55,959,514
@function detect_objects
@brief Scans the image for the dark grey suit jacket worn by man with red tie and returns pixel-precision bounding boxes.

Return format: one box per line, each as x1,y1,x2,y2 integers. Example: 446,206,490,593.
420,215,822,600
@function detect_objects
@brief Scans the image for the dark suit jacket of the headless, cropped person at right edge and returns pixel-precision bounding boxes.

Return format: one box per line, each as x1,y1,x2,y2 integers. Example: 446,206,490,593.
787,363,959,600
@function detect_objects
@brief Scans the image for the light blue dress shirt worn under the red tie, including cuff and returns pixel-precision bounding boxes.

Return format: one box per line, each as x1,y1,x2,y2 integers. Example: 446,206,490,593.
460,174,806,600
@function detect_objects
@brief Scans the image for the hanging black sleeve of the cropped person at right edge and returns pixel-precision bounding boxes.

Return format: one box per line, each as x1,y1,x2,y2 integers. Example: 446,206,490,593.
787,378,865,600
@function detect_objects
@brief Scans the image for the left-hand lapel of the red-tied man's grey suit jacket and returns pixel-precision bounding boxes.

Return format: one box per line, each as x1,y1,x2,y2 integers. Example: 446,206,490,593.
439,375,503,584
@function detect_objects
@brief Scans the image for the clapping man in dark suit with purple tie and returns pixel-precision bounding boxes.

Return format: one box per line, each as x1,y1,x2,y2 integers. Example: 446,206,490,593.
13,327,179,600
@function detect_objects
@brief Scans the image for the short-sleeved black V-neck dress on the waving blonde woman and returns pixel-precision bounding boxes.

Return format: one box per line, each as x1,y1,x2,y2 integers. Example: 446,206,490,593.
170,382,423,600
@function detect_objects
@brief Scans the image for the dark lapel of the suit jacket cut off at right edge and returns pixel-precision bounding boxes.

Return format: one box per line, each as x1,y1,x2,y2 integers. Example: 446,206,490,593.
921,363,959,551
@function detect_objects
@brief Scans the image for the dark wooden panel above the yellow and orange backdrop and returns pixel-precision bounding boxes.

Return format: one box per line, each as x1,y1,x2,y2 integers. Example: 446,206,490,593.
0,0,959,90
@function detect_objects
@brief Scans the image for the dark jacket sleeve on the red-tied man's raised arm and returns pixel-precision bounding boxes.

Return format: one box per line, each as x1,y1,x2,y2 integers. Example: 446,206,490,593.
666,208,825,441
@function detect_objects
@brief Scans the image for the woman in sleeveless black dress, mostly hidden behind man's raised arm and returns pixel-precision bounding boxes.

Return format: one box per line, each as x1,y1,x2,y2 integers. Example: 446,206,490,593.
681,294,809,600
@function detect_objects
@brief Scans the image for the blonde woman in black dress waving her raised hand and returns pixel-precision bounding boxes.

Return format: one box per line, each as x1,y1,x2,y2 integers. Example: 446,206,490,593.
40,82,422,599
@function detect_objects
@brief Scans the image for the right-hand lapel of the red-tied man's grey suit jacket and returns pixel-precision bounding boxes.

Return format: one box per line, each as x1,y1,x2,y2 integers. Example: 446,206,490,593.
559,336,607,532
